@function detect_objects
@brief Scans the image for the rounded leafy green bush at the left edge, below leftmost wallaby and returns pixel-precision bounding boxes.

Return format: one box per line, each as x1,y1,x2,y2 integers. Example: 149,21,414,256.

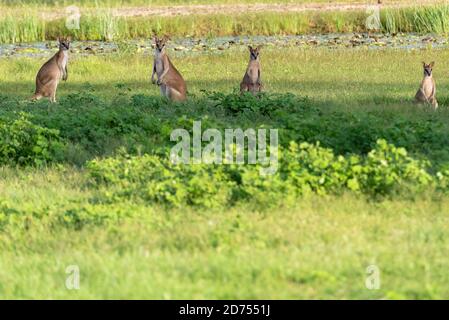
0,113,64,165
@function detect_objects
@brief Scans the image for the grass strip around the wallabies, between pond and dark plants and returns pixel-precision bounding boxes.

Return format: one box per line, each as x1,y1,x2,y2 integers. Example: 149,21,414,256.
0,46,449,104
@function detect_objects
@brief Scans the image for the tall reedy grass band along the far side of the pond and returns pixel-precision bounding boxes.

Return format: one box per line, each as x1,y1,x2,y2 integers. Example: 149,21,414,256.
0,4,449,43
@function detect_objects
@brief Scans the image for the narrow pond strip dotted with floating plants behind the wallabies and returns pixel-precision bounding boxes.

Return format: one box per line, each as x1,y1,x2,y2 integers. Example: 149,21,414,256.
0,33,449,58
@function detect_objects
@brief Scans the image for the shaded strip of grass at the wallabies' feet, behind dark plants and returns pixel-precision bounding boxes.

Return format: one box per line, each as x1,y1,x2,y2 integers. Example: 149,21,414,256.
0,78,449,107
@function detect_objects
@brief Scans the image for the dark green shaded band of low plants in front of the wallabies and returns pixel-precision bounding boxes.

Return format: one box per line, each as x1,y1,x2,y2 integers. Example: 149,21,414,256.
0,88,449,168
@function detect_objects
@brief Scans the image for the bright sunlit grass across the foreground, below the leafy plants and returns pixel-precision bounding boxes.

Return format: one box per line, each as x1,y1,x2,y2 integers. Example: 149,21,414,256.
0,174,449,299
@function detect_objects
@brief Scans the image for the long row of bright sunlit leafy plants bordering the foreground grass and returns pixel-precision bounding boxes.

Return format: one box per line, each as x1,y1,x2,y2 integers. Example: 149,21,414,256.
87,140,441,207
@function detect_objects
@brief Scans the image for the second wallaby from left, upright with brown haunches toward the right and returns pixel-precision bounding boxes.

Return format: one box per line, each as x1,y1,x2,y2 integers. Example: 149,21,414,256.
151,37,187,101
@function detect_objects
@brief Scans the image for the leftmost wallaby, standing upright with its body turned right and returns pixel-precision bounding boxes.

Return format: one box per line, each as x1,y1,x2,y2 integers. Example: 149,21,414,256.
31,38,70,102
